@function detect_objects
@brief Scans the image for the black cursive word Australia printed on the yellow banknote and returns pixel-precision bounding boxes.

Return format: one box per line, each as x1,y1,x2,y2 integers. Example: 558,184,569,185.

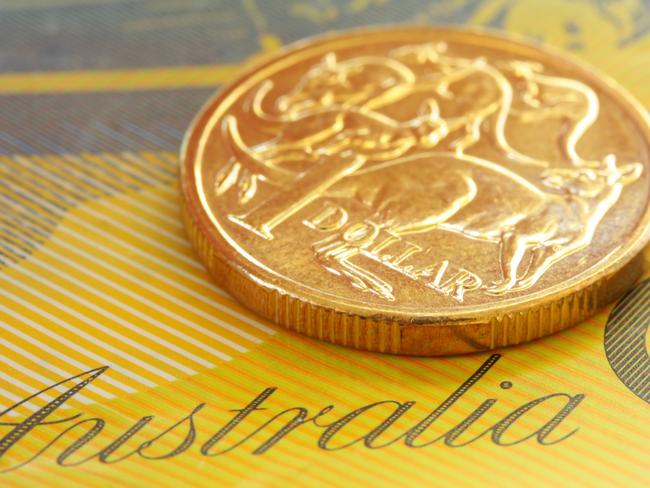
0,354,585,472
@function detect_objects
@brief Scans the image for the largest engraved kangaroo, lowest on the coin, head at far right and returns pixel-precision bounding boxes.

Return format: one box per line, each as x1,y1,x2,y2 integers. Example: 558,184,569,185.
315,153,643,299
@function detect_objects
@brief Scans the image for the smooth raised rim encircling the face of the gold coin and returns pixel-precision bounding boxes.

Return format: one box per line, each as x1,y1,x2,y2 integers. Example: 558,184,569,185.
181,25,650,325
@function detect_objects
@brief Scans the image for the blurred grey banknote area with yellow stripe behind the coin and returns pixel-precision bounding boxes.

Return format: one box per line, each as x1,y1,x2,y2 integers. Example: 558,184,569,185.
0,0,650,158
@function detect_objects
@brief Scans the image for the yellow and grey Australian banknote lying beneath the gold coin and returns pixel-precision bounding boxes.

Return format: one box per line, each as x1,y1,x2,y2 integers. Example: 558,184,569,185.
0,0,650,487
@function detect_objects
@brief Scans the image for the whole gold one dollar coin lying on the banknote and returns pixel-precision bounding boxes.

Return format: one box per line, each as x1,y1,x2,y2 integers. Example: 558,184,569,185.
181,28,650,355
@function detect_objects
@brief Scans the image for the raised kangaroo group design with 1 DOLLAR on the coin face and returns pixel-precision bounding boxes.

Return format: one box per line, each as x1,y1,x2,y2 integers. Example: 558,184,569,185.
213,42,643,302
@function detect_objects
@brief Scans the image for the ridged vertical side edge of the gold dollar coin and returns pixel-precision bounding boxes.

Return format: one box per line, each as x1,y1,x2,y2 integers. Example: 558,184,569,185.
181,187,643,356
